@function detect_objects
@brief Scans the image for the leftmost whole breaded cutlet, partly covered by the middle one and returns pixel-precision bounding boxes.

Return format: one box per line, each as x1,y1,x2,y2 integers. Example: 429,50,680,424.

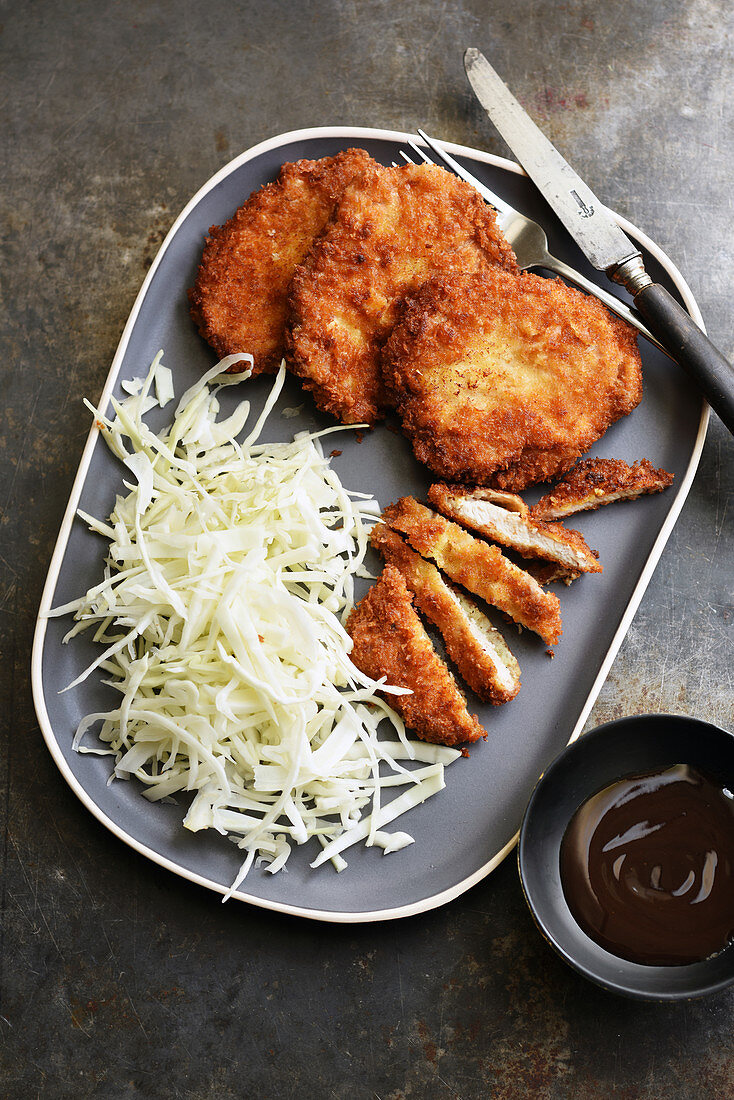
189,149,372,374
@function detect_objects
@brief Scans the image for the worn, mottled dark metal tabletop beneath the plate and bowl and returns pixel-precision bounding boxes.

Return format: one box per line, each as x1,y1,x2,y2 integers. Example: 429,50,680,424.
0,0,734,1100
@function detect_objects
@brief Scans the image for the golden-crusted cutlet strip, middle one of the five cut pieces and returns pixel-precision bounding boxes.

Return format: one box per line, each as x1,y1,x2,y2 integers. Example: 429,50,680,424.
382,496,561,646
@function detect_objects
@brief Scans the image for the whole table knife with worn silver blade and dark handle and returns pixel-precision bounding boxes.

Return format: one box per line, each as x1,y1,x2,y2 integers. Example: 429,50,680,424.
464,48,734,435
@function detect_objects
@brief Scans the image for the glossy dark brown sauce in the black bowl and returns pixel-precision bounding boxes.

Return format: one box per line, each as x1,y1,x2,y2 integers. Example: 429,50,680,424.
560,765,734,966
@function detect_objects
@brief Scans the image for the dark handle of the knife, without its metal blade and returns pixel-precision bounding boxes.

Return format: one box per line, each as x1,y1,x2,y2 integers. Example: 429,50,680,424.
635,283,734,435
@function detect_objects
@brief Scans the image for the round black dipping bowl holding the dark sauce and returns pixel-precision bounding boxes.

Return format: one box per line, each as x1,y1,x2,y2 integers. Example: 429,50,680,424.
517,714,734,1001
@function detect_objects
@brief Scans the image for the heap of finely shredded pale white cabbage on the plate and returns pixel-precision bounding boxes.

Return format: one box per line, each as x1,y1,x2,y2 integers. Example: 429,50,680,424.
52,353,459,897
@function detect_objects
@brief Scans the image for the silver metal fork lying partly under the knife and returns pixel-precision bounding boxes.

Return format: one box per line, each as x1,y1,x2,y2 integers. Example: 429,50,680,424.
401,130,670,355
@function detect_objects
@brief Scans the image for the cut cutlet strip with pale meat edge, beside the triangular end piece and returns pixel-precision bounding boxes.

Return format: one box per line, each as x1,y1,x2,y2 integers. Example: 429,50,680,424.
370,524,519,705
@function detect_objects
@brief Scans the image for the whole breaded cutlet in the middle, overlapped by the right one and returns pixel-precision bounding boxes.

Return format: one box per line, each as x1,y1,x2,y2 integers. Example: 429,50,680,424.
288,163,517,424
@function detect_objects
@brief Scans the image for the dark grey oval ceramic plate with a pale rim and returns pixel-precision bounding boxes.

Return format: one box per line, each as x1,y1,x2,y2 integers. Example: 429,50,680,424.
33,128,708,921
